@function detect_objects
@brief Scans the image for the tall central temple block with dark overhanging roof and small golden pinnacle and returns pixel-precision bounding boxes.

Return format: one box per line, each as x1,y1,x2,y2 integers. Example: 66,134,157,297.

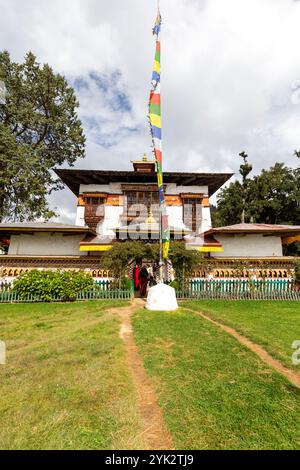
56,157,232,253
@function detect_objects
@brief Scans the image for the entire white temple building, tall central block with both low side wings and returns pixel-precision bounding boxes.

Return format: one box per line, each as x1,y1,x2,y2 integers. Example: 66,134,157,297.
0,156,300,280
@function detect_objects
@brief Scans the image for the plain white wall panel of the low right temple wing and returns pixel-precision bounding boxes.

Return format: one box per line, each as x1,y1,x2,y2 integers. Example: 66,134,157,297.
213,234,282,258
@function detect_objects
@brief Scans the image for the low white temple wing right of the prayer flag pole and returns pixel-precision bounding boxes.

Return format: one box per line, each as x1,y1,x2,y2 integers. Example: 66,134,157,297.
185,223,300,278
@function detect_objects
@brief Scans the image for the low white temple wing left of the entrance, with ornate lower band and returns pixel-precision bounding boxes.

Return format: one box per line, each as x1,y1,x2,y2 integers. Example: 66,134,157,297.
0,222,109,281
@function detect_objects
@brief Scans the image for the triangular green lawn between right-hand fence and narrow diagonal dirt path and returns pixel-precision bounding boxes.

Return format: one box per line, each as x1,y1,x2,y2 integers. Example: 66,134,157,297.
182,300,300,372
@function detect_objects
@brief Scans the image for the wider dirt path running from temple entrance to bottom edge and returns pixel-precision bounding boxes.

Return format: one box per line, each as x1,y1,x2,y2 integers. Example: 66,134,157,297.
110,299,174,450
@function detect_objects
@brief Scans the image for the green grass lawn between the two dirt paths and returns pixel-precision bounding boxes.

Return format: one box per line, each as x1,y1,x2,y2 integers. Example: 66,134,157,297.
133,310,300,449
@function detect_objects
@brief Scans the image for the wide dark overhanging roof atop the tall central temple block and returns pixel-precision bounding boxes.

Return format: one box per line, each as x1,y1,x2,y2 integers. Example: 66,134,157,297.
54,169,233,196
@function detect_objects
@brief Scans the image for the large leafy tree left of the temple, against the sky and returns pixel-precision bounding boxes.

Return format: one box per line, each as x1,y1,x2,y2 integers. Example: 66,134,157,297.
0,51,85,221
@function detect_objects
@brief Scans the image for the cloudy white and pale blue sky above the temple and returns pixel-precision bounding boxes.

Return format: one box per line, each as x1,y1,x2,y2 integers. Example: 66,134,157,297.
0,0,300,222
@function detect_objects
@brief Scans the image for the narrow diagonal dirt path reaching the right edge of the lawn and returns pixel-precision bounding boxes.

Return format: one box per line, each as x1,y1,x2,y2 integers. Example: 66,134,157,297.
184,308,300,388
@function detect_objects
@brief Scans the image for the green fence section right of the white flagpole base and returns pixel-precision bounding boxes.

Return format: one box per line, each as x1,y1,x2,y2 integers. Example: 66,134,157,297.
177,279,300,300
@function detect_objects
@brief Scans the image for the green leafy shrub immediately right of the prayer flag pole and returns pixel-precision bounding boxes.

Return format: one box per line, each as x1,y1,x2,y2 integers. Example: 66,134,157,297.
169,241,204,289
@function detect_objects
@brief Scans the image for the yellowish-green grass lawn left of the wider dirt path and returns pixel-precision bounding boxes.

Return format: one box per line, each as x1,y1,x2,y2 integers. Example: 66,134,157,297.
0,301,144,449
